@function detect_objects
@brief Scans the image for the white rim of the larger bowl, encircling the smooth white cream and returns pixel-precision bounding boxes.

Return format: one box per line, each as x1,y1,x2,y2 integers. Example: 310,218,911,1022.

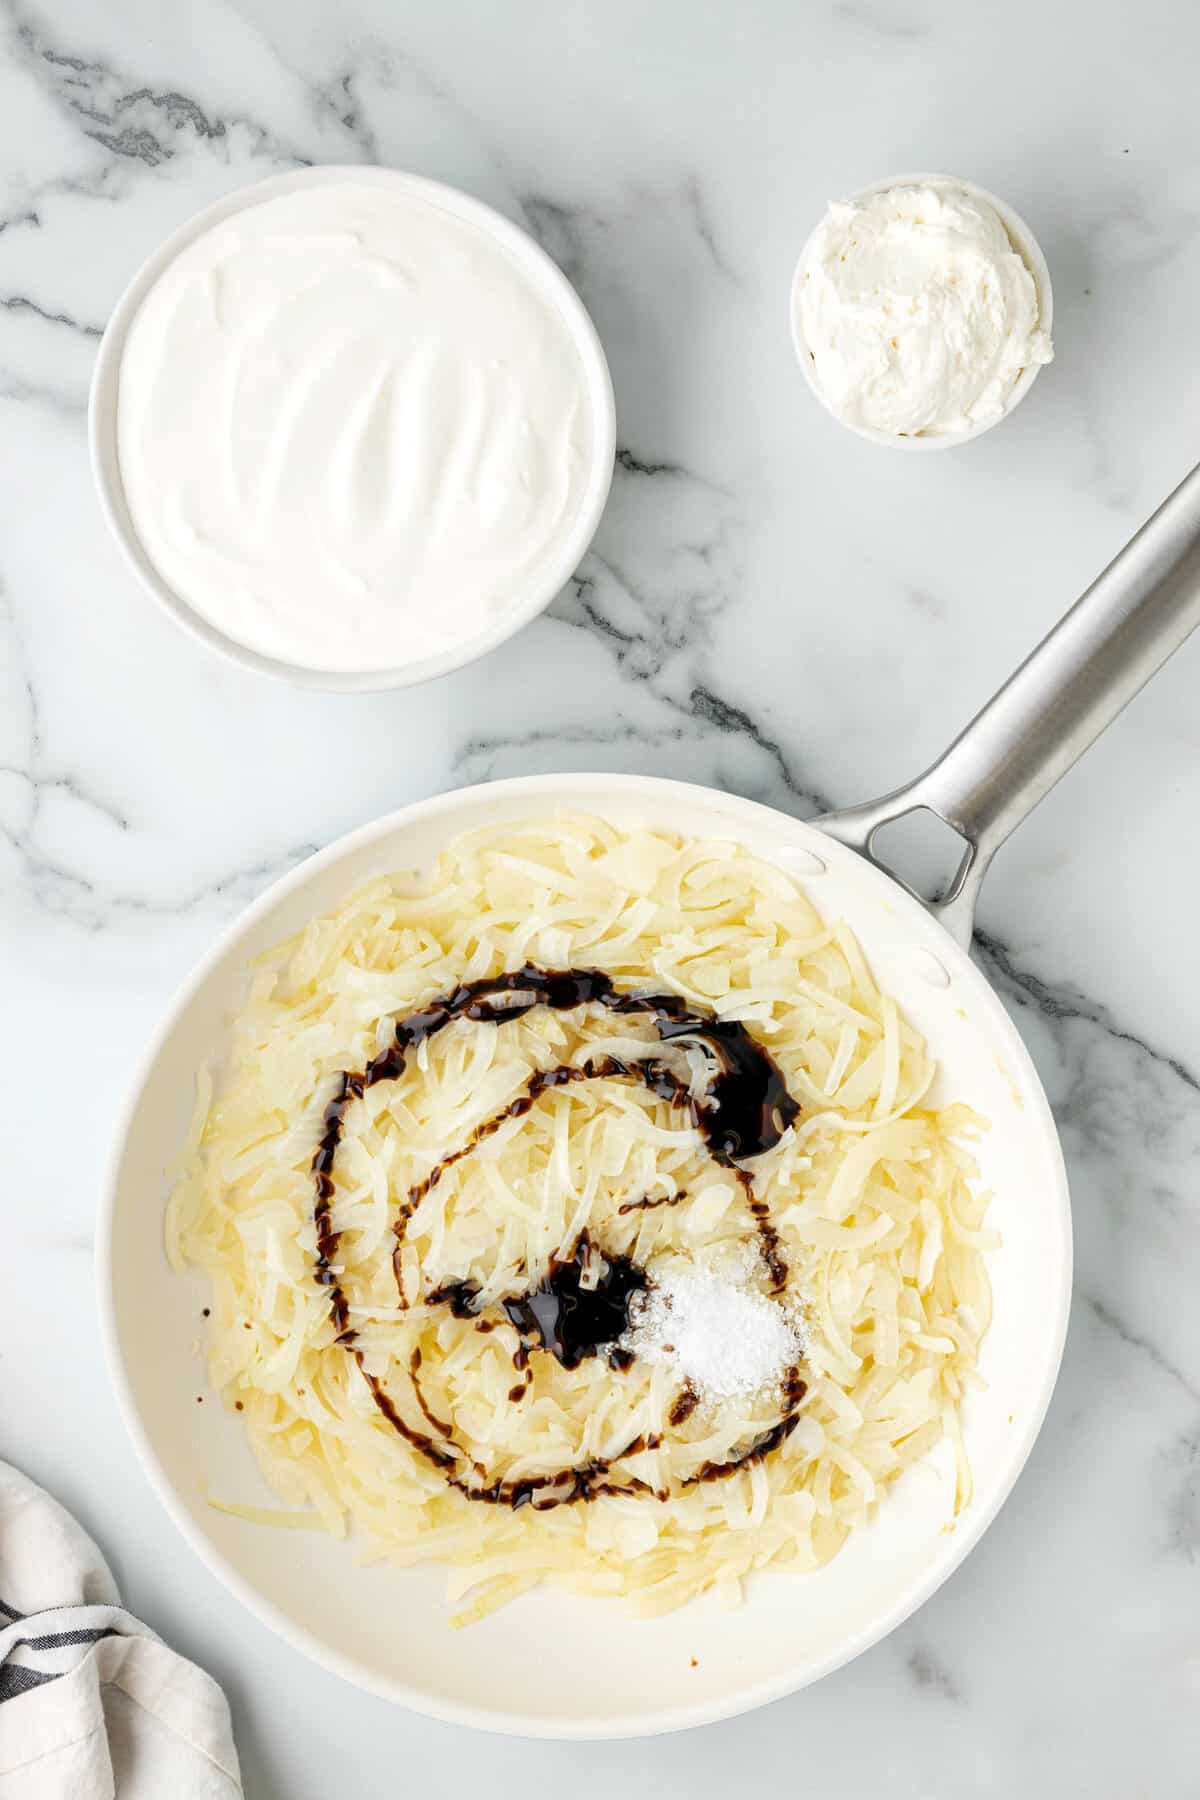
88,164,617,693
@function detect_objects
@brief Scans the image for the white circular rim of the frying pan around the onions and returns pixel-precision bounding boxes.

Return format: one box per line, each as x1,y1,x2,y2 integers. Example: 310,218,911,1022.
95,772,1072,1741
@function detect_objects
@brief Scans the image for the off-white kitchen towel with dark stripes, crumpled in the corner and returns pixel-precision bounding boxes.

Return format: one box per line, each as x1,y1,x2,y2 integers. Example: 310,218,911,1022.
0,1462,241,1800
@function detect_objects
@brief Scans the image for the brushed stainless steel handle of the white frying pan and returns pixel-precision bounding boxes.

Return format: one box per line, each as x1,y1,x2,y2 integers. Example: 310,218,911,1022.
813,466,1200,949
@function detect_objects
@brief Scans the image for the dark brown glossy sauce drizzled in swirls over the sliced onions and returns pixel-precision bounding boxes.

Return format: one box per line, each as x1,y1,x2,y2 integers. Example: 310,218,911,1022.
311,963,806,1510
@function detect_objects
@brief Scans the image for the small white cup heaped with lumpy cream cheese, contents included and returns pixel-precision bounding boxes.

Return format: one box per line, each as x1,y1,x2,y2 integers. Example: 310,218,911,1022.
792,175,1052,450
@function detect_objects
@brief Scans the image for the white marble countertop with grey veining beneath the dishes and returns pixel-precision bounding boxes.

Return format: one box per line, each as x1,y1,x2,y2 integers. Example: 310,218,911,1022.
0,0,1200,1800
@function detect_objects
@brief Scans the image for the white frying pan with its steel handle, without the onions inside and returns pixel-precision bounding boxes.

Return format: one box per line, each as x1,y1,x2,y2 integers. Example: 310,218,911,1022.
99,472,1200,1737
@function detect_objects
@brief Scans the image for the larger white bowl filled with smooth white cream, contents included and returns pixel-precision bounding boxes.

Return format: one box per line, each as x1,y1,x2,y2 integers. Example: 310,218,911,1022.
90,169,613,689
